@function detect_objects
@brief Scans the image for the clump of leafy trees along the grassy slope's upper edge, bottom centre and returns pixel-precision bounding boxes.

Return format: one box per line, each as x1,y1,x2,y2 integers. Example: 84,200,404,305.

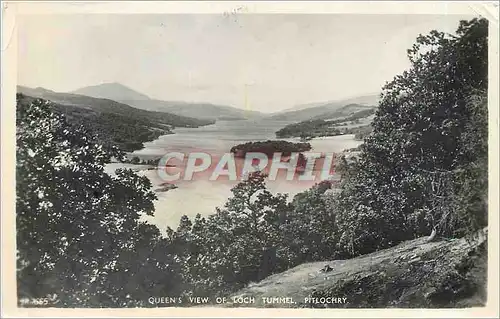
167,176,344,296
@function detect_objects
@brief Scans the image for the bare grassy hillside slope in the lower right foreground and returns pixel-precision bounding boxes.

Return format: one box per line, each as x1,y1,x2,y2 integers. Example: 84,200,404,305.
226,228,487,308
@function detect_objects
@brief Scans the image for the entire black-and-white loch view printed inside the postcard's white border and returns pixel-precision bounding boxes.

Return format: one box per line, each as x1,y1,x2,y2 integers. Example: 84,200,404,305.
15,12,491,308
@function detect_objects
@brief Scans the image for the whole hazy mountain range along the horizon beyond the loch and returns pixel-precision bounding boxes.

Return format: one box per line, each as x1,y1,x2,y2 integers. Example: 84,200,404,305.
18,83,380,122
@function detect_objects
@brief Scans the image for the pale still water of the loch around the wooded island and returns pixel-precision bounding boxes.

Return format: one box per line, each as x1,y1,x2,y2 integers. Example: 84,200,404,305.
107,120,360,230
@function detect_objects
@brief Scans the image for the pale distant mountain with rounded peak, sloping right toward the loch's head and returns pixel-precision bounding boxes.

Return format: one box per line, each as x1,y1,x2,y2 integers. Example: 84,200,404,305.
72,83,263,120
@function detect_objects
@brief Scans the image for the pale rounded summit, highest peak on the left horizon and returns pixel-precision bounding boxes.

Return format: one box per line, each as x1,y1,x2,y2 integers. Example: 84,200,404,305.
70,83,150,101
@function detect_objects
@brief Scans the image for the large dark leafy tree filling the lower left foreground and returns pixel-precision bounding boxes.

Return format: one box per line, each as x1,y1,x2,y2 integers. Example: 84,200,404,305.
16,95,184,307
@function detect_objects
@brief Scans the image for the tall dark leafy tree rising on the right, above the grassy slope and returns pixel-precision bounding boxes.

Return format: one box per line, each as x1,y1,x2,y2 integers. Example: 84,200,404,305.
336,19,488,255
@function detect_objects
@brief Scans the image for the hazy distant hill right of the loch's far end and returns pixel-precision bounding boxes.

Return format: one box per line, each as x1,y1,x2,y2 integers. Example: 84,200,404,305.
268,94,379,121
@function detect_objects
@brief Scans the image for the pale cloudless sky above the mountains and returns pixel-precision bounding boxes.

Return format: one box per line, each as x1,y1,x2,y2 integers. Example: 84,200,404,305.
17,14,471,113
